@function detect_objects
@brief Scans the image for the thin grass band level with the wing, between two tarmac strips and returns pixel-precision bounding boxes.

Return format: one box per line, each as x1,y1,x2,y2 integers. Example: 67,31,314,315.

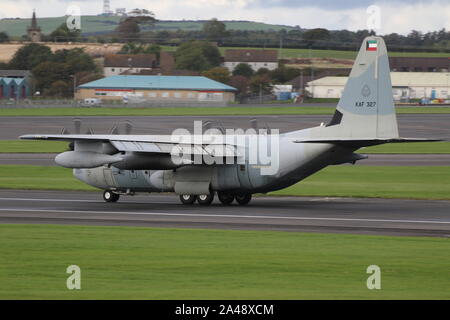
0,140,450,154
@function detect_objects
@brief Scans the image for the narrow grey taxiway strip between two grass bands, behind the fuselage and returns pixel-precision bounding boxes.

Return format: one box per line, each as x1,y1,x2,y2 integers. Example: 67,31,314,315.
0,150,450,166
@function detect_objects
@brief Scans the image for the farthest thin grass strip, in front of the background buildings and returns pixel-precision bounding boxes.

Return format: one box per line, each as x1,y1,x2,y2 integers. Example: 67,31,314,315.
0,104,450,117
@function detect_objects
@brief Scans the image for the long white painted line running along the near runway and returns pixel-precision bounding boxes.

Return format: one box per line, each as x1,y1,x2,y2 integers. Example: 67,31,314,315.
0,208,450,224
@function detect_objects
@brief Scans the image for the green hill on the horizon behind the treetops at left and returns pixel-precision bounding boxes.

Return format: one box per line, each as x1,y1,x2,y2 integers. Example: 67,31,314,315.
0,16,293,37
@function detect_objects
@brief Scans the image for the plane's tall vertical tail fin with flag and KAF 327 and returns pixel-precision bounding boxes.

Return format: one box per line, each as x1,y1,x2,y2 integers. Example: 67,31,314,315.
328,37,398,138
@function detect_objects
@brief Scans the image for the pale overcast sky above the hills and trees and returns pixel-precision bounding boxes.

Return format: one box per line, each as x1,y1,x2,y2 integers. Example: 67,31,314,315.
0,0,450,34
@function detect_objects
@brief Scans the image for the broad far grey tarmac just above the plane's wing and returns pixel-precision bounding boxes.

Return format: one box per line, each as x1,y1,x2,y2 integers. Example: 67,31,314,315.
0,114,450,140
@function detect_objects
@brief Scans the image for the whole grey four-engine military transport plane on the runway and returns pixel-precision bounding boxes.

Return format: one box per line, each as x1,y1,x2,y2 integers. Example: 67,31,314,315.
20,37,436,205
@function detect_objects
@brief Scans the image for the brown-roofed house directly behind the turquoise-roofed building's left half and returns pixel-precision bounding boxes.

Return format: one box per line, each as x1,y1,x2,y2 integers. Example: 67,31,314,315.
103,54,157,77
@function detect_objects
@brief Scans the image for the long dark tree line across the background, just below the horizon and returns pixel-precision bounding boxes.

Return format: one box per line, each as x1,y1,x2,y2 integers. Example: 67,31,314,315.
0,14,450,52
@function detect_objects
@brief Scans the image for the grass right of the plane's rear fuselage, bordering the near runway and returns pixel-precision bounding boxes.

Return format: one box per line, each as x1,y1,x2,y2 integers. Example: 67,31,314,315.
272,165,450,199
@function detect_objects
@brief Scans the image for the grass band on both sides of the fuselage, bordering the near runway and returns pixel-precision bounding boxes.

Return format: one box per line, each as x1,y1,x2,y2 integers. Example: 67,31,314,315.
0,165,450,200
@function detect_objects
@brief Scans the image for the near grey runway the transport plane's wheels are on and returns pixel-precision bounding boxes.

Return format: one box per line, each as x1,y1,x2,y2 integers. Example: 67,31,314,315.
0,190,450,237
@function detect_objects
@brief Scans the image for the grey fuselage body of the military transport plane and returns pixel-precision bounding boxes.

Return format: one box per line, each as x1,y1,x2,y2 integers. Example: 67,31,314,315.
73,129,358,194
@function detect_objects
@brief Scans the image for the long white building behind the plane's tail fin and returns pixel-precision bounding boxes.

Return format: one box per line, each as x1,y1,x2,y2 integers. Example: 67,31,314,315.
306,72,450,101
